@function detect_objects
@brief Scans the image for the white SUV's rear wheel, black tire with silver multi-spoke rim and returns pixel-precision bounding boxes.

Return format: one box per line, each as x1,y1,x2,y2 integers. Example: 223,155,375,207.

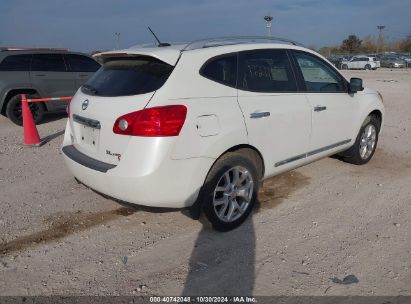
200,152,259,232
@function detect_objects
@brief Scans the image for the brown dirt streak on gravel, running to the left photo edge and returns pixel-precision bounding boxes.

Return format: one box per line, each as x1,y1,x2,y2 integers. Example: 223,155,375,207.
0,207,137,255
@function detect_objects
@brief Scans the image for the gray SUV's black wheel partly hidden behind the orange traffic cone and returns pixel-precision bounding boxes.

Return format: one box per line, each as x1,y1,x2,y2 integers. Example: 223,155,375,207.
6,95,45,126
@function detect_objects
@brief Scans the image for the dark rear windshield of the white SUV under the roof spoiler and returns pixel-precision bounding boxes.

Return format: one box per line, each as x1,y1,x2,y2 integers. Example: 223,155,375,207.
81,57,173,97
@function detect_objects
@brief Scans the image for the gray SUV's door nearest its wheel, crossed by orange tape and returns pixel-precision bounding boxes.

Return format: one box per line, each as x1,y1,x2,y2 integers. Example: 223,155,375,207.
30,54,76,110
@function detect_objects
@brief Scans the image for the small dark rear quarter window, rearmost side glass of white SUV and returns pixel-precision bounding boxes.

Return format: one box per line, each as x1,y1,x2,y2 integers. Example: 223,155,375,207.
200,54,237,87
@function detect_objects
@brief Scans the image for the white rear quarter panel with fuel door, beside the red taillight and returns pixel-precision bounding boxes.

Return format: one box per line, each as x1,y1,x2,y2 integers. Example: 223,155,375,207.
148,50,247,159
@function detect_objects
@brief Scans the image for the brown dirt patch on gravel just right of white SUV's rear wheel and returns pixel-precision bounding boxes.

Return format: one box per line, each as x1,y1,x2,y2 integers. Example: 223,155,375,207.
256,171,310,211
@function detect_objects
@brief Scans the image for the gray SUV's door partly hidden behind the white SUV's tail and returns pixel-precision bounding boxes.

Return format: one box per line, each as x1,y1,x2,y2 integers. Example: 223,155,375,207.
64,54,100,89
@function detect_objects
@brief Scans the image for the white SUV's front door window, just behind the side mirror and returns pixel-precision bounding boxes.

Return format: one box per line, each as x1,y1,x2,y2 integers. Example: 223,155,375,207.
294,51,346,92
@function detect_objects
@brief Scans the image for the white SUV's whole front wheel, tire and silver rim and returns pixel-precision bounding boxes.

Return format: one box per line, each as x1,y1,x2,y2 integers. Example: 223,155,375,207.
342,115,380,165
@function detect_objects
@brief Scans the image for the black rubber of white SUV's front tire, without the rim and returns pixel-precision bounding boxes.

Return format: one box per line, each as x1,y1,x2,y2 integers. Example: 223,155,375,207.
342,115,381,165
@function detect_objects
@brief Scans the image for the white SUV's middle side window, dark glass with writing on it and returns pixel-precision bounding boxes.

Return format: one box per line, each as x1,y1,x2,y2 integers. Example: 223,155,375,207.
238,49,296,92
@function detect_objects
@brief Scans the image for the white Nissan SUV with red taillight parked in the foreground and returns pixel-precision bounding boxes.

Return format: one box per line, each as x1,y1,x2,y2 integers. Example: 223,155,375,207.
62,37,384,231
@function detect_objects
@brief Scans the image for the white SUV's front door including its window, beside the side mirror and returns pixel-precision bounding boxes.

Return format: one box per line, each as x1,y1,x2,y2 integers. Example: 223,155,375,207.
293,51,358,156
